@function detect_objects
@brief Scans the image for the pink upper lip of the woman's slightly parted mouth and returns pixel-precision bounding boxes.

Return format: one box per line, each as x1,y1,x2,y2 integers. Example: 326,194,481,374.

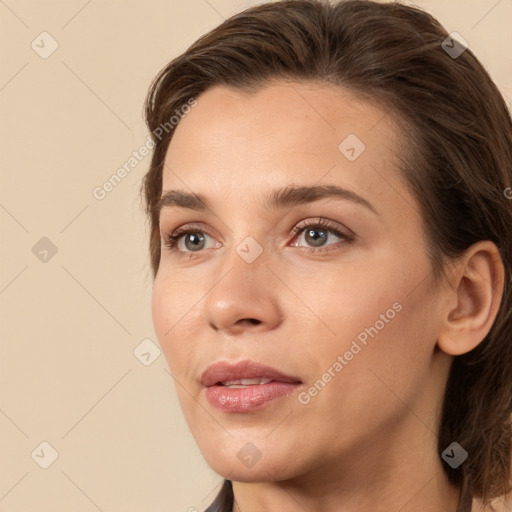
201,360,302,387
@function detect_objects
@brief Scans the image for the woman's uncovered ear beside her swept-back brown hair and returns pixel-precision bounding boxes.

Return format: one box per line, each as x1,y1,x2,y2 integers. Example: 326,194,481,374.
437,240,505,356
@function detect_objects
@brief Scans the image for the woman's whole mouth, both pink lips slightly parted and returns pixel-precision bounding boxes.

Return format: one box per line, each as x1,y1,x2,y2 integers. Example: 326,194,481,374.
201,361,303,413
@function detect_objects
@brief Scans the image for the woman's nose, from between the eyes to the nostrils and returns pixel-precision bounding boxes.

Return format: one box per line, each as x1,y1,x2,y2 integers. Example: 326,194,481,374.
204,249,283,335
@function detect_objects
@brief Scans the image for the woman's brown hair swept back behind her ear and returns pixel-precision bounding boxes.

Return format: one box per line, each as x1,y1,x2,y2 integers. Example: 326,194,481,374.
142,0,512,504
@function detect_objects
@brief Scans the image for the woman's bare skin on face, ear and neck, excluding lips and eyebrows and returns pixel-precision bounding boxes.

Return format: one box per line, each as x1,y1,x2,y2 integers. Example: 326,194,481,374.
152,82,503,512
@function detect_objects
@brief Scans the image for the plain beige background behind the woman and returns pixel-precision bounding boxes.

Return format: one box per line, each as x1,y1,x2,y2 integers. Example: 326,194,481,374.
0,0,512,512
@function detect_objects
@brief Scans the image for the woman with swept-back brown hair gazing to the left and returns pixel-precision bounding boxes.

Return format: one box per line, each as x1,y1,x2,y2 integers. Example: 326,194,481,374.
143,0,512,512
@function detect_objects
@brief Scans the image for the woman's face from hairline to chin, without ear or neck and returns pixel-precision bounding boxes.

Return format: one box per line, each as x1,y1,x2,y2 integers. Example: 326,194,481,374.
152,82,450,481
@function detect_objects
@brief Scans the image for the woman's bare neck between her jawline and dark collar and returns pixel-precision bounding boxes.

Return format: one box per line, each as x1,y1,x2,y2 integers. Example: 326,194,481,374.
233,415,460,512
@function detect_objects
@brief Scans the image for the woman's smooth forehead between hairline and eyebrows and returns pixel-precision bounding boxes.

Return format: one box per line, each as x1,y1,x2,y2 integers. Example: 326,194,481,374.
163,82,411,216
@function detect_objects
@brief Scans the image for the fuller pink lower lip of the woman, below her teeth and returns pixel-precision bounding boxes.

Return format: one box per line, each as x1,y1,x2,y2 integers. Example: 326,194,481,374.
206,382,300,412
